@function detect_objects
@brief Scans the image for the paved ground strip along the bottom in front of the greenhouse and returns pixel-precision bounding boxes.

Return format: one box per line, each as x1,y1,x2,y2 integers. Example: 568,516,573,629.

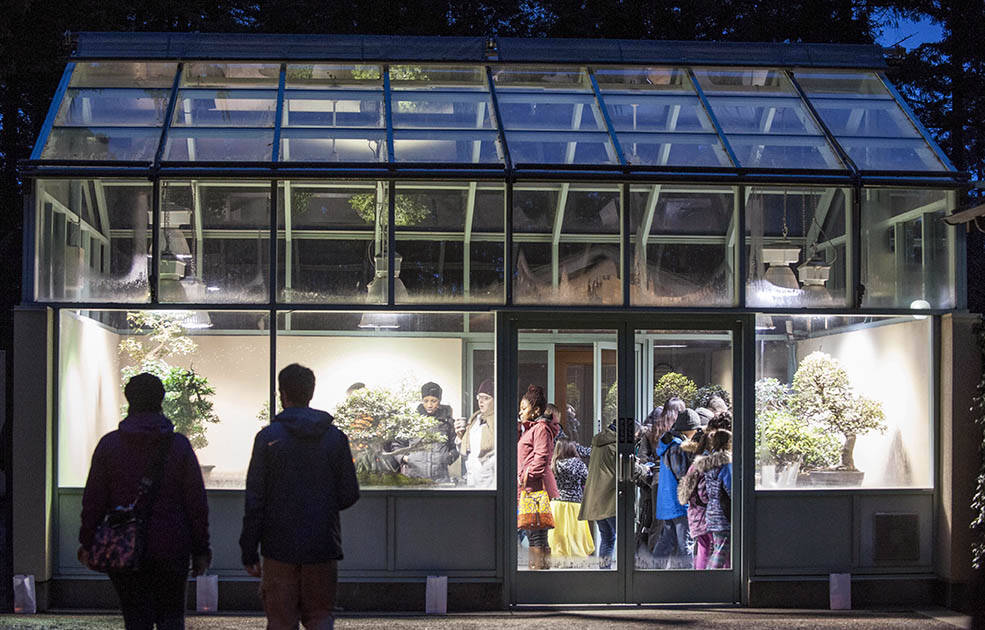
0,607,969,630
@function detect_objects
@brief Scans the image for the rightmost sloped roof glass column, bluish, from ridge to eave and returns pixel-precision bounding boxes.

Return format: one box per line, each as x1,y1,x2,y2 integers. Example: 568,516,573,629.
795,70,947,171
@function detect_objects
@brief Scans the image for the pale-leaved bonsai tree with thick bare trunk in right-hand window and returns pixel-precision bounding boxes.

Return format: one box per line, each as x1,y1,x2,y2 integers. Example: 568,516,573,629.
789,352,886,470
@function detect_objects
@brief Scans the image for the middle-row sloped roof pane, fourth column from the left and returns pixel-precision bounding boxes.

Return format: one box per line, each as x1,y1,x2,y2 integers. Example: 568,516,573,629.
390,90,496,129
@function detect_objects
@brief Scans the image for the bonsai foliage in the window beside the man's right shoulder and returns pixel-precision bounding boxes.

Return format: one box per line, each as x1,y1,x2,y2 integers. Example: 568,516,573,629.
332,383,446,447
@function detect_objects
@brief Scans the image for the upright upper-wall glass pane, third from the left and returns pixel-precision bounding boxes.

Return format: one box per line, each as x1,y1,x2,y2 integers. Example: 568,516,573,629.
277,181,388,304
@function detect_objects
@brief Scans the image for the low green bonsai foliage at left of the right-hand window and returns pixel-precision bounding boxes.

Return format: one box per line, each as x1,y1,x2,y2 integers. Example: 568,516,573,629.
756,408,841,469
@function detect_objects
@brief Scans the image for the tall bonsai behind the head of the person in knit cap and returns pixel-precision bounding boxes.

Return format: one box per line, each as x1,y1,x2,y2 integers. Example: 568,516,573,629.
118,311,219,449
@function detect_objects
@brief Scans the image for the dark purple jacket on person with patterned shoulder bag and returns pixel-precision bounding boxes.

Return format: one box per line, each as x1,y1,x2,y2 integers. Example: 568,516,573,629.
79,413,209,571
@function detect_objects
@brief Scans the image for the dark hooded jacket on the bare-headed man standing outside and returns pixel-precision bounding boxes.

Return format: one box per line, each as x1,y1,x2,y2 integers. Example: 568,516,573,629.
239,407,359,566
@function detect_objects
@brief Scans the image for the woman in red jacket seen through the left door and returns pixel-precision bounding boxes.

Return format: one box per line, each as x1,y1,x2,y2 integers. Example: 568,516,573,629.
516,385,561,570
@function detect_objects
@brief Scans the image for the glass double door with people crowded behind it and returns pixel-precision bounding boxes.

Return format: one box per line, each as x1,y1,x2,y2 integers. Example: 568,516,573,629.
498,313,744,605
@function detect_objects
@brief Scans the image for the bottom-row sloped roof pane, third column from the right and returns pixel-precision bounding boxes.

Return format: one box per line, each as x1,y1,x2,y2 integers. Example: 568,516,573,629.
617,133,731,166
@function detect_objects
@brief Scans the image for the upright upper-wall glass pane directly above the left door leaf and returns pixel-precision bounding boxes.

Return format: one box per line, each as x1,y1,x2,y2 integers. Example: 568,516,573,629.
511,183,623,305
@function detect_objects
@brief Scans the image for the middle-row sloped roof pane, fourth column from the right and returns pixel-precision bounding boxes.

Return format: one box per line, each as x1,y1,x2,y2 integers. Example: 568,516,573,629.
498,92,605,131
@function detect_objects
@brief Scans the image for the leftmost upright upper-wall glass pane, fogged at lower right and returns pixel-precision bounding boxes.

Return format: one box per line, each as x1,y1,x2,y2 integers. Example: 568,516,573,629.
34,179,153,302
